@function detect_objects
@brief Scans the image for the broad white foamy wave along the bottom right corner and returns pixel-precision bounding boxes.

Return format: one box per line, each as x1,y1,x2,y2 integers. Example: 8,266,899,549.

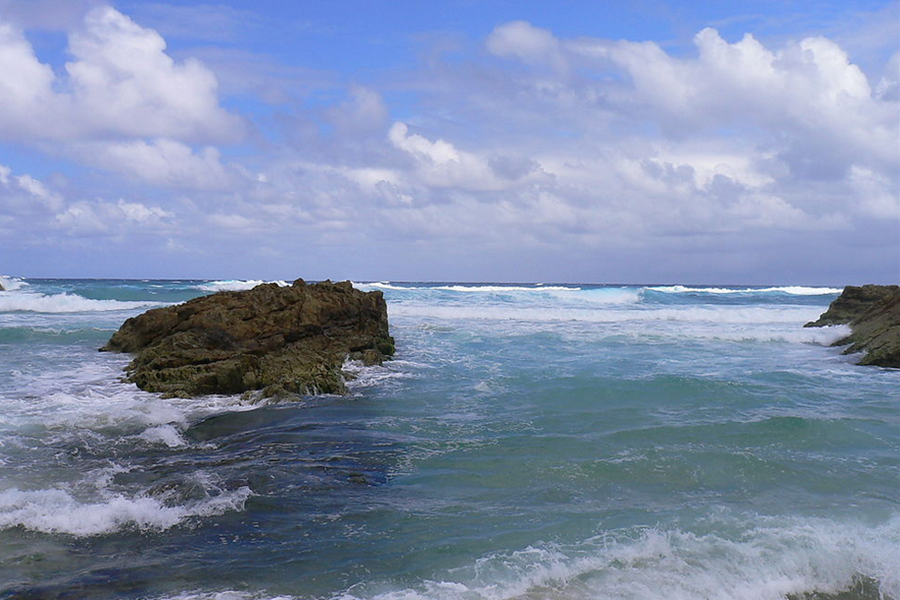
335,517,900,600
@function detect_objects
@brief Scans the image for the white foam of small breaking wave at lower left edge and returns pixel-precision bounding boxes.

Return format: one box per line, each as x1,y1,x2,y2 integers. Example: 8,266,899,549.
0,487,251,536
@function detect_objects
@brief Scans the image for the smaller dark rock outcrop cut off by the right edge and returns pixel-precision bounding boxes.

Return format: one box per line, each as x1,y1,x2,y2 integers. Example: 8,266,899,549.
806,285,900,368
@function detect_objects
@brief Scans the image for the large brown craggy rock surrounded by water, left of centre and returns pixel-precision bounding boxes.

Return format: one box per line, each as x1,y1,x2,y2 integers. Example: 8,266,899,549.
100,279,394,397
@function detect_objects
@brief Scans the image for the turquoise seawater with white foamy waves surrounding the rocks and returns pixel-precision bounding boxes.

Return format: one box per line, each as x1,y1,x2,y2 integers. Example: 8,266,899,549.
0,277,900,600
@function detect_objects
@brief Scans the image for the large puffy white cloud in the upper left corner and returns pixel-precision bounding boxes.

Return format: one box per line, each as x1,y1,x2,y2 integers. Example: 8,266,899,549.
0,6,243,142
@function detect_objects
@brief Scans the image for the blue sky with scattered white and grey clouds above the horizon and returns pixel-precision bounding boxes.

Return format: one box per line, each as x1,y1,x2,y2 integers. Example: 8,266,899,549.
0,0,900,286
